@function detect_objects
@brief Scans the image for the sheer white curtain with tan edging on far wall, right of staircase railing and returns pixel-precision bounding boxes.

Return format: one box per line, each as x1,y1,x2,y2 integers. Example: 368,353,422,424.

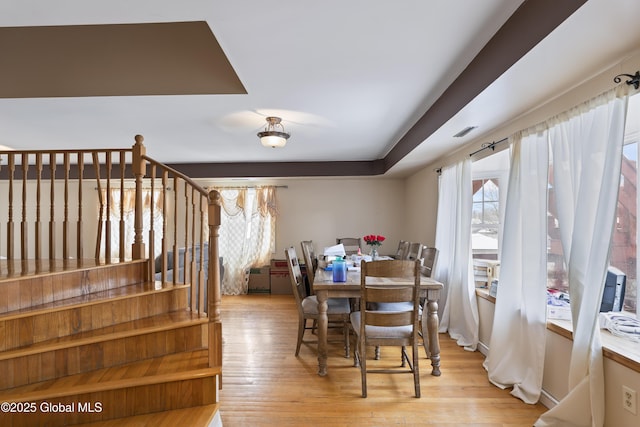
217,186,277,295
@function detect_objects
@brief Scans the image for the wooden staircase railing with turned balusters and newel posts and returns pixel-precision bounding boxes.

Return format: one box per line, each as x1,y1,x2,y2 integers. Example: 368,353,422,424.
0,135,222,367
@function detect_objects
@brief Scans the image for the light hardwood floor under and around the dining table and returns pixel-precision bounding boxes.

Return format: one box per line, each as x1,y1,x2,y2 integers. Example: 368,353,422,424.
220,294,546,427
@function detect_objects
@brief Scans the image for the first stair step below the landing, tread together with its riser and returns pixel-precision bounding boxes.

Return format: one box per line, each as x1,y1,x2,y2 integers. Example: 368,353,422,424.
0,282,189,351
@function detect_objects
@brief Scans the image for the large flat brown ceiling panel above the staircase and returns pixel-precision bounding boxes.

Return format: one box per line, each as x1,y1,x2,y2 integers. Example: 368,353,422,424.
0,21,247,98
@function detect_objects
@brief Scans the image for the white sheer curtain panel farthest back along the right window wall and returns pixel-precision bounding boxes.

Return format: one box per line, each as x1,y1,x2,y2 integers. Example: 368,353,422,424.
434,159,479,351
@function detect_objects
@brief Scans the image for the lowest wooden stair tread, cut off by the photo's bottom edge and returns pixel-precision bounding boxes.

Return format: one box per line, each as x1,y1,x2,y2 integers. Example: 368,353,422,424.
78,404,219,427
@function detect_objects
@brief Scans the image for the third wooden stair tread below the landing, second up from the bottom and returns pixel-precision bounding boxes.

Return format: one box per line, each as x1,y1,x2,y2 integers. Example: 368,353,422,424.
0,349,221,402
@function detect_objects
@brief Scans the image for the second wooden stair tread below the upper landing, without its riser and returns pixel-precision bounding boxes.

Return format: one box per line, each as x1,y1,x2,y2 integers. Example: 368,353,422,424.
0,310,208,360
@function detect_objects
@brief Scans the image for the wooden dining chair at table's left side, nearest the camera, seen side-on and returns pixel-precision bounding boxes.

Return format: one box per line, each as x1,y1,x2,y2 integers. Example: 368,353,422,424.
285,247,351,357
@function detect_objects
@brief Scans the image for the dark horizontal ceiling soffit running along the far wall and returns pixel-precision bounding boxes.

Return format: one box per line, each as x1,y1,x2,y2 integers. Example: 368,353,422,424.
167,160,384,178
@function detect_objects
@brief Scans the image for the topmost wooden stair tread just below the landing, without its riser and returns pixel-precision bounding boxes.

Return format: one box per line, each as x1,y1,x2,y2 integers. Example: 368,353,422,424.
0,281,189,321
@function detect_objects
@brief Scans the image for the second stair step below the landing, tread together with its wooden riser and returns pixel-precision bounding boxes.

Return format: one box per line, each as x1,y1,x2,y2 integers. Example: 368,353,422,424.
0,310,208,389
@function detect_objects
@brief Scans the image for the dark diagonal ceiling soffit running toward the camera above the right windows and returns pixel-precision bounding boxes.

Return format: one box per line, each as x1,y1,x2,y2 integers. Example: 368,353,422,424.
384,0,587,172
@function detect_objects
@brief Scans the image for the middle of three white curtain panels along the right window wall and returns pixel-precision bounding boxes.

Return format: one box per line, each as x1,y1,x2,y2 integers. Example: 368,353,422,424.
484,127,549,404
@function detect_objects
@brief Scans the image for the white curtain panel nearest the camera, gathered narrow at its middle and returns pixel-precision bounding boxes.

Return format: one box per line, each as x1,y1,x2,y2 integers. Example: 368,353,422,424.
535,85,627,427
